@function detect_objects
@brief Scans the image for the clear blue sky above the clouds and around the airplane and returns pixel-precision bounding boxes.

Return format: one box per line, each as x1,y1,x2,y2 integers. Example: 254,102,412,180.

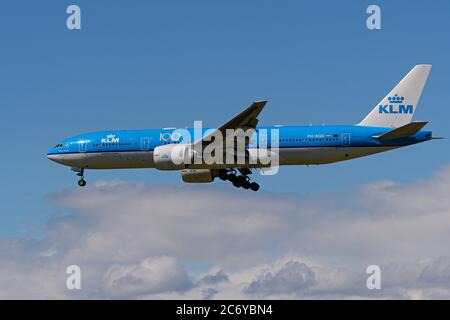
0,0,450,237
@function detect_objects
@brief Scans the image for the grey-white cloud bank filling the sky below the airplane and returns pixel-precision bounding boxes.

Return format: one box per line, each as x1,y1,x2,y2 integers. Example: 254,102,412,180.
0,167,450,299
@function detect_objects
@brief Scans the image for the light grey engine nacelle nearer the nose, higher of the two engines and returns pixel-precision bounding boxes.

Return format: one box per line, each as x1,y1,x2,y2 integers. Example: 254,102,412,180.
153,144,192,170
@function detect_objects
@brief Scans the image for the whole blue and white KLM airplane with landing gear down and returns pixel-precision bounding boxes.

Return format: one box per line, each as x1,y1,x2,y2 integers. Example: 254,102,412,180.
47,64,438,191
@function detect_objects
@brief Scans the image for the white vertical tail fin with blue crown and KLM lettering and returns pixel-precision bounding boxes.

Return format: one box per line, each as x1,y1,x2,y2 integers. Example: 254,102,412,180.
358,64,431,128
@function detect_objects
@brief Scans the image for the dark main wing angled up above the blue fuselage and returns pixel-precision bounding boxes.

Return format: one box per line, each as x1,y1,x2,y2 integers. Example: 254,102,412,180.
193,101,267,149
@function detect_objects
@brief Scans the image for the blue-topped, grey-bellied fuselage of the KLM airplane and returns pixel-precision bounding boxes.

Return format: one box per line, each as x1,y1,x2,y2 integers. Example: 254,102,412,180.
47,125,432,169
